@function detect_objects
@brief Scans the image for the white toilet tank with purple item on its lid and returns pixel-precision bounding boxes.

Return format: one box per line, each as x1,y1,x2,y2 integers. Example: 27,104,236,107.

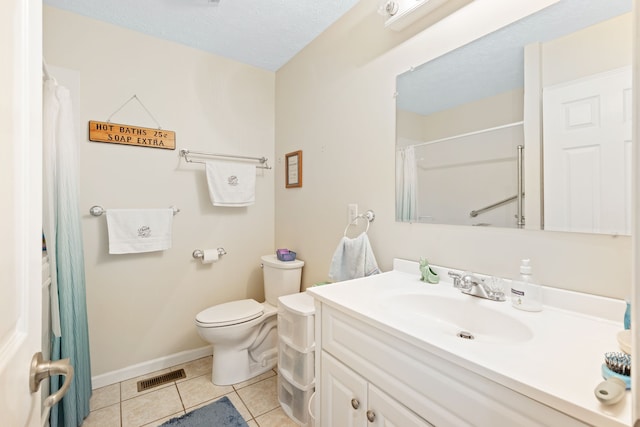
261,254,304,307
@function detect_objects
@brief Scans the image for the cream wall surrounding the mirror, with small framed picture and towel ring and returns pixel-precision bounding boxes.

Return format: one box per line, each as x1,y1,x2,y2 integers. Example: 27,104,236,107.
275,0,631,298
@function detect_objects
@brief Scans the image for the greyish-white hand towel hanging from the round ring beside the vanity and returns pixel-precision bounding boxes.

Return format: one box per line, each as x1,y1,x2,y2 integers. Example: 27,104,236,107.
329,233,380,282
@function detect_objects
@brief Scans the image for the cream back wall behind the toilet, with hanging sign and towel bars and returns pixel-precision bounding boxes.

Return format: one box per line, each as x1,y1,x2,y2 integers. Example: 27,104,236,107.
44,6,275,376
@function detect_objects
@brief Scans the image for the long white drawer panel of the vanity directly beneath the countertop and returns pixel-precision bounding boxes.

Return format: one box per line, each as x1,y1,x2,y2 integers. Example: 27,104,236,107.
321,305,585,427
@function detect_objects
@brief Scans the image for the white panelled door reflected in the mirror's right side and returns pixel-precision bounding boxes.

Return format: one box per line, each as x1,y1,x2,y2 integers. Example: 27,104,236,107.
543,67,632,234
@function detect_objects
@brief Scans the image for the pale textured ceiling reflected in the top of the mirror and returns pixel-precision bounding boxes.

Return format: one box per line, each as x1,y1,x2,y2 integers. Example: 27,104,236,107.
397,0,632,115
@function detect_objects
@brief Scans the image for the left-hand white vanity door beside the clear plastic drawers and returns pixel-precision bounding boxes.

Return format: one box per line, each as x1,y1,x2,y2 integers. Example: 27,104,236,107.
320,351,367,427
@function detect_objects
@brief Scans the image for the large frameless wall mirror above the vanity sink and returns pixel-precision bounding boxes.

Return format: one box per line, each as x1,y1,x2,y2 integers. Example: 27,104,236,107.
396,0,632,234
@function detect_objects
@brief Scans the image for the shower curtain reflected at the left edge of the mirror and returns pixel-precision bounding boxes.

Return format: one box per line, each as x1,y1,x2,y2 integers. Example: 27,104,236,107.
396,145,418,222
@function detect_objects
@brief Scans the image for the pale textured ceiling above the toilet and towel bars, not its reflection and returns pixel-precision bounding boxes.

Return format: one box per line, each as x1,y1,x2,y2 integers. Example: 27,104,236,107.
44,0,364,71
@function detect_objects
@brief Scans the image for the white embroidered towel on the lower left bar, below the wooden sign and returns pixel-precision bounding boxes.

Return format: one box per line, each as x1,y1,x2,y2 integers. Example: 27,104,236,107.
107,208,173,254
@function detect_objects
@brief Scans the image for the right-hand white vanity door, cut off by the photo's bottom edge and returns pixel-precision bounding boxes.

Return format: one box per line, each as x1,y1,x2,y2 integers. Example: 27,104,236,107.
367,384,433,427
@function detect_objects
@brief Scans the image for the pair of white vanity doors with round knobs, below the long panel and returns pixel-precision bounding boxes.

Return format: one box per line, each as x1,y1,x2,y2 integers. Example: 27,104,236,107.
317,352,433,427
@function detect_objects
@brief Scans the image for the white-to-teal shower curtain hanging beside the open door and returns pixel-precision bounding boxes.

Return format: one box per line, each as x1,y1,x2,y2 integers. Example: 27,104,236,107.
42,76,91,427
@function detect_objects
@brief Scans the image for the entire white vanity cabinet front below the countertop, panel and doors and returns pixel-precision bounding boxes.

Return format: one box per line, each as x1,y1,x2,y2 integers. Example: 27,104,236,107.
315,302,588,427
